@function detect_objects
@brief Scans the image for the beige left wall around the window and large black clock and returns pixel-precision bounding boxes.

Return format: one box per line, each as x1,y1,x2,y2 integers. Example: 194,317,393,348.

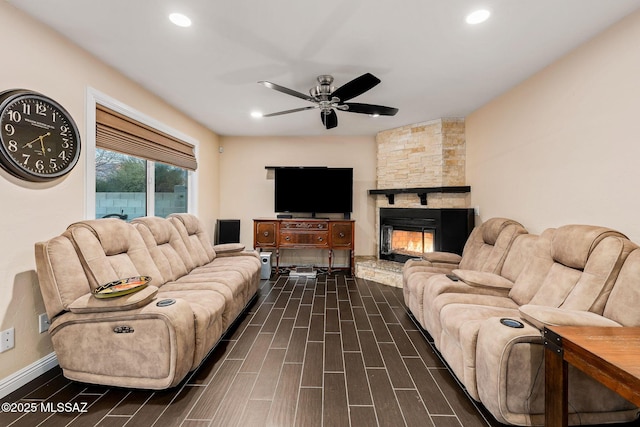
0,2,218,380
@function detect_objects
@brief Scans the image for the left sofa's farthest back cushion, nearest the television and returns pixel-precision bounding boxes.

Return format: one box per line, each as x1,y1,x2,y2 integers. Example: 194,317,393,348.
168,213,216,270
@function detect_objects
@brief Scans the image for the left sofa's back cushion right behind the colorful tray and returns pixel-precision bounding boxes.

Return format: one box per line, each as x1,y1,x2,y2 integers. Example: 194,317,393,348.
65,218,166,290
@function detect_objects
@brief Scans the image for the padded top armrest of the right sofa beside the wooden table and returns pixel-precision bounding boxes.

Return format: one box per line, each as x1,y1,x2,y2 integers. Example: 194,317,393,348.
520,304,622,330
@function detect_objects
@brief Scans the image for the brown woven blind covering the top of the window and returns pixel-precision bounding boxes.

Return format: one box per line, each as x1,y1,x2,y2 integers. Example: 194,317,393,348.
96,104,198,171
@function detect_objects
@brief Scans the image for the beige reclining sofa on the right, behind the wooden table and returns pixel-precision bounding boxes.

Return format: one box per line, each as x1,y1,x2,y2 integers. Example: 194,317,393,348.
404,219,640,425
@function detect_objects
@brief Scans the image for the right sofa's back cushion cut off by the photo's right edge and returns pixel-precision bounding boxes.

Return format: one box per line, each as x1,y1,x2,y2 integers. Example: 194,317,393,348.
602,249,640,326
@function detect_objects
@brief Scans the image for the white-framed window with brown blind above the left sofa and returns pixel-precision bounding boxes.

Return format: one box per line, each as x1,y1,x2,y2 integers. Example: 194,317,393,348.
85,89,197,220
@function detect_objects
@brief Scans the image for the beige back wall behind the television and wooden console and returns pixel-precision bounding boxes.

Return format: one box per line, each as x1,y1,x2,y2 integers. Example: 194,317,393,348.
220,135,376,262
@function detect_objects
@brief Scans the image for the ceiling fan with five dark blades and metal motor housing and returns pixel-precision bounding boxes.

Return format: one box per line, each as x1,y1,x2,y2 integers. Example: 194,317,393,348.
258,73,398,129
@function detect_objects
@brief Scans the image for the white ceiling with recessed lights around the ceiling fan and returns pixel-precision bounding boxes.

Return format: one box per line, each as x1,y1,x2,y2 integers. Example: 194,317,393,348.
7,0,640,136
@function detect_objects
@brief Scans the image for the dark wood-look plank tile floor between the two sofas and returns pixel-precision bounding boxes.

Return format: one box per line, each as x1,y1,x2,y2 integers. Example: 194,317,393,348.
0,275,636,427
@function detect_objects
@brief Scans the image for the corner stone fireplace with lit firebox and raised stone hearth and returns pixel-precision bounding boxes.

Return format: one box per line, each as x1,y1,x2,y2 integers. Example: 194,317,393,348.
356,118,474,287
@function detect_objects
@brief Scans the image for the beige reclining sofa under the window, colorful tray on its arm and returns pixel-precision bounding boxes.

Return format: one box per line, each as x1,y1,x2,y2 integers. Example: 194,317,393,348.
35,214,261,389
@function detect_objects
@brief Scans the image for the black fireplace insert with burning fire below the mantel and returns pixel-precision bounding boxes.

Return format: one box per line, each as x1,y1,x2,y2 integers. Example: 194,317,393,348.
379,208,474,262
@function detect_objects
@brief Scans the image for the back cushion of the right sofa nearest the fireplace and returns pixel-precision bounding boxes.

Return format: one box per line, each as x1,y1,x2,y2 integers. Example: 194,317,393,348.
459,218,527,274
